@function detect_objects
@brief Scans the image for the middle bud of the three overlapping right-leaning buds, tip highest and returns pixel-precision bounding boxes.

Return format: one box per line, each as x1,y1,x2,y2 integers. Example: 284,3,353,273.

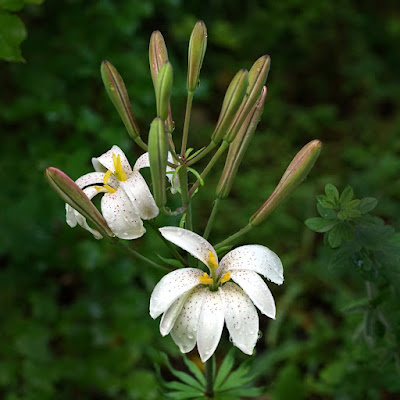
224,55,271,143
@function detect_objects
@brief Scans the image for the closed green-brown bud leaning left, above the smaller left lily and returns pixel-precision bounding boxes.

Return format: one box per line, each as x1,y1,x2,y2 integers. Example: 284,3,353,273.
100,61,140,140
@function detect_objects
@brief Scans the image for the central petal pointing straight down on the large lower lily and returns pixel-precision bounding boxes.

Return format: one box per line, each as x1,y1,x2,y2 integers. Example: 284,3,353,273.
197,290,224,363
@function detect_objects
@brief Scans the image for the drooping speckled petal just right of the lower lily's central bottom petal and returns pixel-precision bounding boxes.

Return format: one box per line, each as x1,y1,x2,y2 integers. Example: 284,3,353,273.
220,282,258,355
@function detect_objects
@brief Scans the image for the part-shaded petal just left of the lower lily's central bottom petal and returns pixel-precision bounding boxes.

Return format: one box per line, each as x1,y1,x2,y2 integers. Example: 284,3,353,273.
171,286,209,353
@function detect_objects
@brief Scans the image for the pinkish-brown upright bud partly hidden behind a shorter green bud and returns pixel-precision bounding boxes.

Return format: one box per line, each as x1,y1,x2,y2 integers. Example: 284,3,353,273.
149,31,175,133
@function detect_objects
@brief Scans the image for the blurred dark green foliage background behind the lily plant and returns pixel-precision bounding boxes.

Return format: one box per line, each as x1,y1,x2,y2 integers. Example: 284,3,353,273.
0,0,400,400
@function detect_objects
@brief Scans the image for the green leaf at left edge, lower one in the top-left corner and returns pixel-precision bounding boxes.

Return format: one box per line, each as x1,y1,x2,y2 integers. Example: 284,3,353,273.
0,11,26,62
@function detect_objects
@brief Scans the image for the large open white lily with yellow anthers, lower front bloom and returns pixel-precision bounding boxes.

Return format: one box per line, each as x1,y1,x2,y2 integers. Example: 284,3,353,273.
150,227,283,362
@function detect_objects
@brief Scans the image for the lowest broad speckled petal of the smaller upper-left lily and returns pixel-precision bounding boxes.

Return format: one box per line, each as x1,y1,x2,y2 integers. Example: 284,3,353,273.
101,189,146,240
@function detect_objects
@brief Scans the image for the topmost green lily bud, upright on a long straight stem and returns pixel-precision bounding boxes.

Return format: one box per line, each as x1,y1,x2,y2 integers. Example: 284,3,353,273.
187,21,207,92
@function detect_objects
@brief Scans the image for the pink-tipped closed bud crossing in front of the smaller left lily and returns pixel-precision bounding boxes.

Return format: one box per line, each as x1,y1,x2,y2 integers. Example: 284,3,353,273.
45,167,115,237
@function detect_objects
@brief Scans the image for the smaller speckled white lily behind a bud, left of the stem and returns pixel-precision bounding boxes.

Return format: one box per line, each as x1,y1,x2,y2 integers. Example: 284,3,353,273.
66,146,158,239
